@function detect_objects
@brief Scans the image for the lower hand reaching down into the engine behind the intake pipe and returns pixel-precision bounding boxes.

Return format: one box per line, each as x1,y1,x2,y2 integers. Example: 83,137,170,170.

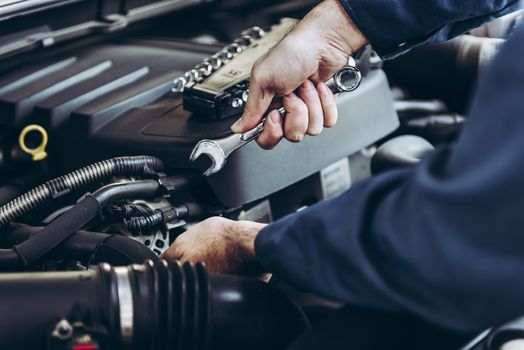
162,217,266,276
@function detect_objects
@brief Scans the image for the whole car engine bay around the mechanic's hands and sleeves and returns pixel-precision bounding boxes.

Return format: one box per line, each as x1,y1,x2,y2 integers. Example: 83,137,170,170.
0,0,516,350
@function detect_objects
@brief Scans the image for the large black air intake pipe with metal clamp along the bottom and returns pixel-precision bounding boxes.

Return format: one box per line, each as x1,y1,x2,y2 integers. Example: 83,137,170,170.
0,261,309,350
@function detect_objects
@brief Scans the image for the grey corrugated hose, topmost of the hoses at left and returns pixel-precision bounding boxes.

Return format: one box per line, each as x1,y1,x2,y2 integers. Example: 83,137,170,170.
0,156,163,228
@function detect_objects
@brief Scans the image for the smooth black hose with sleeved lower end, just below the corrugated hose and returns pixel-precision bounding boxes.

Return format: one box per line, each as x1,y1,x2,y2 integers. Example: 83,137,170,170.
0,180,160,267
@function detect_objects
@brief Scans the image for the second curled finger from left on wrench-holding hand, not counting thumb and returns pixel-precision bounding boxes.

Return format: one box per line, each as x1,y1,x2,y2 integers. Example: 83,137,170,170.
283,93,309,142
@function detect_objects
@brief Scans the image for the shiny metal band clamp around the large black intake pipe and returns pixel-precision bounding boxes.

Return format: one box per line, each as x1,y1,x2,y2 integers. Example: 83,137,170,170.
114,267,134,345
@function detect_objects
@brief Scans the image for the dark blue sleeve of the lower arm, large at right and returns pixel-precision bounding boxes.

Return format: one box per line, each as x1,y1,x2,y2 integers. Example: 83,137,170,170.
255,25,524,332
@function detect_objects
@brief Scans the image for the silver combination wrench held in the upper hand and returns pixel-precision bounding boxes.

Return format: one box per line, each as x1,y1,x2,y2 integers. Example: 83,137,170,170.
190,65,362,176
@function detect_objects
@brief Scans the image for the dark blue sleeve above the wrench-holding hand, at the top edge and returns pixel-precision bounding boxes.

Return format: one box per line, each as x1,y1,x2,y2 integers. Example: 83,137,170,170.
340,0,519,59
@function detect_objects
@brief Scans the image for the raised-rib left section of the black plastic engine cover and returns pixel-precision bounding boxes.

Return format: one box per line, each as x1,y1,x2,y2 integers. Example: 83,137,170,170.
0,40,216,130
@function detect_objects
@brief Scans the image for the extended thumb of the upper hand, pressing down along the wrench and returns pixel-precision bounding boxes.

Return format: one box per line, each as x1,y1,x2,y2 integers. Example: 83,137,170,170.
231,63,275,133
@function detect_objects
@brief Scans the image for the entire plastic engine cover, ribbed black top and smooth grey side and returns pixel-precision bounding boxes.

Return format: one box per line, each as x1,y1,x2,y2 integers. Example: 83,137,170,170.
0,40,398,207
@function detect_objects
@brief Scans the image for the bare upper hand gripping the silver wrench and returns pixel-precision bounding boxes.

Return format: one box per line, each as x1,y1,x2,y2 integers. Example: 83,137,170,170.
231,0,366,149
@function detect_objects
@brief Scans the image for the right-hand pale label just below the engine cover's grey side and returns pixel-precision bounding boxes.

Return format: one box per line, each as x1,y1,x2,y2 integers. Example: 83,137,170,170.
320,158,351,199
